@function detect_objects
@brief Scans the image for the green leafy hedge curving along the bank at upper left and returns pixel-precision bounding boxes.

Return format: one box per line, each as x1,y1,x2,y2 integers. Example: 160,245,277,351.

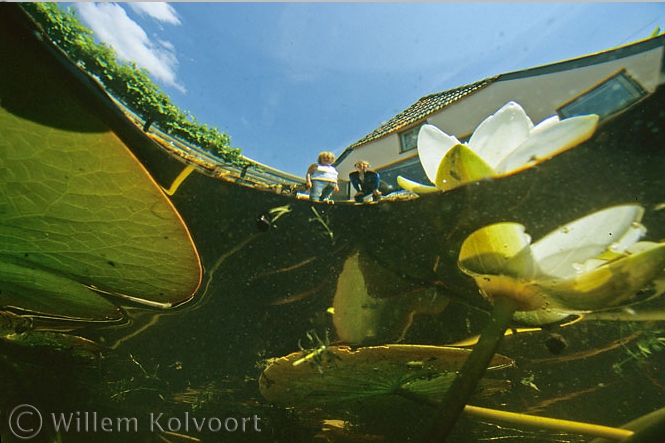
22,3,248,166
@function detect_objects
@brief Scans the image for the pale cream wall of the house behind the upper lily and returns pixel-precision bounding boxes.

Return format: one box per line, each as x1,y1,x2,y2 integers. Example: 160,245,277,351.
337,46,665,196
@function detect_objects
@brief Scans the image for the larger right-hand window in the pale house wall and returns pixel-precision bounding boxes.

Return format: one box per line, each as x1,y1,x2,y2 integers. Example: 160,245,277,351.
557,70,647,120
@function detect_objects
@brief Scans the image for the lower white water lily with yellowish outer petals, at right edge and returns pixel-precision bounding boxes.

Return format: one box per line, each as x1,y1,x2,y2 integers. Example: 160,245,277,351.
458,205,665,316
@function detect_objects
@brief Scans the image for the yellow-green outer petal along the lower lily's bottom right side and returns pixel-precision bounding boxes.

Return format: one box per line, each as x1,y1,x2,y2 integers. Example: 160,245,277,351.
539,242,665,312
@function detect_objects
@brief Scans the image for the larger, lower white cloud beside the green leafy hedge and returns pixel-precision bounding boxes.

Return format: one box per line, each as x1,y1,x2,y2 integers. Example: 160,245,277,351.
76,3,185,93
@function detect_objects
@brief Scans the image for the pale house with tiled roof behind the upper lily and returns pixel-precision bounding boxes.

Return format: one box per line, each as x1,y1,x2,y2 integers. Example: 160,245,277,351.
335,34,665,196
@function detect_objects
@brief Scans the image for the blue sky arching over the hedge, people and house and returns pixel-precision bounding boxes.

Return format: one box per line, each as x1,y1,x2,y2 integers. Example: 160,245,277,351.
68,2,665,176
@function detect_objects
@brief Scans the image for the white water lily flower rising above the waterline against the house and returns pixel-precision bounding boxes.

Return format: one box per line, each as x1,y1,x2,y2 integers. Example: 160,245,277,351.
397,101,598,193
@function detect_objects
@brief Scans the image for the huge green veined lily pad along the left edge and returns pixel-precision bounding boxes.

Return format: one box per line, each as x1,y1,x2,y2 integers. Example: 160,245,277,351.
0,18,201,321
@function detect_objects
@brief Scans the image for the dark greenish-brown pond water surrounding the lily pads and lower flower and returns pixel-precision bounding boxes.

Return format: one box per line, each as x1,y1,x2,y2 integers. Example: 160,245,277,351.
0,3,665,442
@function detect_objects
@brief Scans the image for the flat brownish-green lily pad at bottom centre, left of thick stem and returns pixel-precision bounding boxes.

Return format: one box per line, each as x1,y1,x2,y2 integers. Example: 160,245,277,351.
259,344,513,408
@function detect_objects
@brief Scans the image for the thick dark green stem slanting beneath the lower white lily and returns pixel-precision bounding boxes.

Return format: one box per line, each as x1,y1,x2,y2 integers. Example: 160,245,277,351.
426,298,515,443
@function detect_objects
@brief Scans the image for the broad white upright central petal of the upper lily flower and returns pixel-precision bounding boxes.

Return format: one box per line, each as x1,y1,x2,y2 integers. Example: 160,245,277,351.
469,101,533,169
